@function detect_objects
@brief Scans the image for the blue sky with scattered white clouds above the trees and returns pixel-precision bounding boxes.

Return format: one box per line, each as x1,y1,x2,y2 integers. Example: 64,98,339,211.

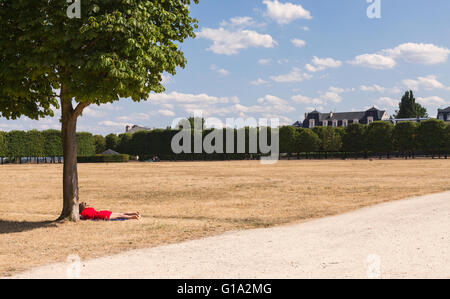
0,0,450,135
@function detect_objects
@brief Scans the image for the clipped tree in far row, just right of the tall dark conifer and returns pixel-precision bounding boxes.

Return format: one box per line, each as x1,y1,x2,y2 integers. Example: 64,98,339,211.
417,119,445,156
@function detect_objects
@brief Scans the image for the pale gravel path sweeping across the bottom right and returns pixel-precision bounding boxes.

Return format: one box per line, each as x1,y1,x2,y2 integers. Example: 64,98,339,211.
9,192,450,278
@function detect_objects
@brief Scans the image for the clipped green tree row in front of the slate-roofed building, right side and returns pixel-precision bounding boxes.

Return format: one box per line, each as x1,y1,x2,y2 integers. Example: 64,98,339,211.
280,119,450,158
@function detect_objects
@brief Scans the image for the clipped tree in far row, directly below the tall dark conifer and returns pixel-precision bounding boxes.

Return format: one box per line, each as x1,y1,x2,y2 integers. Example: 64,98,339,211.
392,122,418,158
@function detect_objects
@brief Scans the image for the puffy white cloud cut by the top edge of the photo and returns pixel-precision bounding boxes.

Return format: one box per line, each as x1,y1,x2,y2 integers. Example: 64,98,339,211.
263,0,312,25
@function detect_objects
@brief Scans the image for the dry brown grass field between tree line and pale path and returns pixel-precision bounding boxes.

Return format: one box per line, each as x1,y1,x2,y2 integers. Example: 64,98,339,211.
0,159,450,276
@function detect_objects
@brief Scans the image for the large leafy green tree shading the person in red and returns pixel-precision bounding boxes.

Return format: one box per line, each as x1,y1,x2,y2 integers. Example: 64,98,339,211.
0,0,198,221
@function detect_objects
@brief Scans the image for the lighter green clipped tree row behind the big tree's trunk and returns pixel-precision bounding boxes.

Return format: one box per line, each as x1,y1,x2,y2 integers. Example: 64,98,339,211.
0,130,96,163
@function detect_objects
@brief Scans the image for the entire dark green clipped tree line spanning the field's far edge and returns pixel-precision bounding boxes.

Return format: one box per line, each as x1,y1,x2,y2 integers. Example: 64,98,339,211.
0,119,450,163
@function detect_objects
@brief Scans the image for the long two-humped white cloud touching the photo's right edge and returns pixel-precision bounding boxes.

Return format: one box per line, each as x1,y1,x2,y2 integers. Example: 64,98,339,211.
349,43,450,70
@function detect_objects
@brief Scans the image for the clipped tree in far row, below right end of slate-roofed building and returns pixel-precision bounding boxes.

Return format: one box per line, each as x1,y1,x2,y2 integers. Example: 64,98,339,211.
366,121,394,157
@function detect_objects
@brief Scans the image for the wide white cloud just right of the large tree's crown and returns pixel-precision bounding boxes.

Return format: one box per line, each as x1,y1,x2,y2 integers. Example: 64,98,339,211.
197,28,277,55
